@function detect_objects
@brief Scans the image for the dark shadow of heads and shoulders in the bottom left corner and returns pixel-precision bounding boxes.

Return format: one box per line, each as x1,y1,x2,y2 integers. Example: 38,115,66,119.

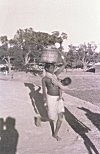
0,117,19,154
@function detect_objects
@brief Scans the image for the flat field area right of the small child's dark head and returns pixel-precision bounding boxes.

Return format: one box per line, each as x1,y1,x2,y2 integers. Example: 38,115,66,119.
62,72,100,106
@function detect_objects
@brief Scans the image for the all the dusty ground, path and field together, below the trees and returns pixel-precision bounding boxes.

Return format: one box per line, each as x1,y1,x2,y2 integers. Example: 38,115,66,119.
0,72,100,154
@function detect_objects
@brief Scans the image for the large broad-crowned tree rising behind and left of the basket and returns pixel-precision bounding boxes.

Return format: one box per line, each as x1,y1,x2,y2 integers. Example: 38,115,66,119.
14,28,62,65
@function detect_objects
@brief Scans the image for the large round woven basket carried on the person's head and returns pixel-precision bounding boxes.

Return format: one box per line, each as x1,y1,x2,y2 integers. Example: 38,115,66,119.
41,49,58,63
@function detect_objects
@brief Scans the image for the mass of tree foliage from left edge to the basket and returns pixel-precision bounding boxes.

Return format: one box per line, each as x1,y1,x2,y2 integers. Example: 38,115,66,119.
0,28,65,71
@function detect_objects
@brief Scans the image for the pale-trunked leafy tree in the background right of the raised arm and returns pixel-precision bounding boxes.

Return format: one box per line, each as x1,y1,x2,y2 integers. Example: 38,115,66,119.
68,42,97,70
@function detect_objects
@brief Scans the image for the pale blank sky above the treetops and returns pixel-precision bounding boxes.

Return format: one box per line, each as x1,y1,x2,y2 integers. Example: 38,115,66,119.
0,0,100,44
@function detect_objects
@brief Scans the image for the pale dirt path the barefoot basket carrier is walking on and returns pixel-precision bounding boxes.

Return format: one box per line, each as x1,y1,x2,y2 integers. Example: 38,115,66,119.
0,80,100,154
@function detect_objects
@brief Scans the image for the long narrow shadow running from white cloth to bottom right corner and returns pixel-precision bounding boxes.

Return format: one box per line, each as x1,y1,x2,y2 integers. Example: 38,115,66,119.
65,107,99,154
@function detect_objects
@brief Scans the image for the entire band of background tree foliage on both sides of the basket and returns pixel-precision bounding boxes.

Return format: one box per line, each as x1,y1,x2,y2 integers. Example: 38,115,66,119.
0,28,100,69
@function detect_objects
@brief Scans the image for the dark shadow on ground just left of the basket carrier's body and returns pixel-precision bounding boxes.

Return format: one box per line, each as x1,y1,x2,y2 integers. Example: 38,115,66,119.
24,83,49,121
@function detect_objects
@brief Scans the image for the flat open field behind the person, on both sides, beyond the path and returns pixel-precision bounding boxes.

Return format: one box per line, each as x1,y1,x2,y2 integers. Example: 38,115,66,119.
1,70,100,106
